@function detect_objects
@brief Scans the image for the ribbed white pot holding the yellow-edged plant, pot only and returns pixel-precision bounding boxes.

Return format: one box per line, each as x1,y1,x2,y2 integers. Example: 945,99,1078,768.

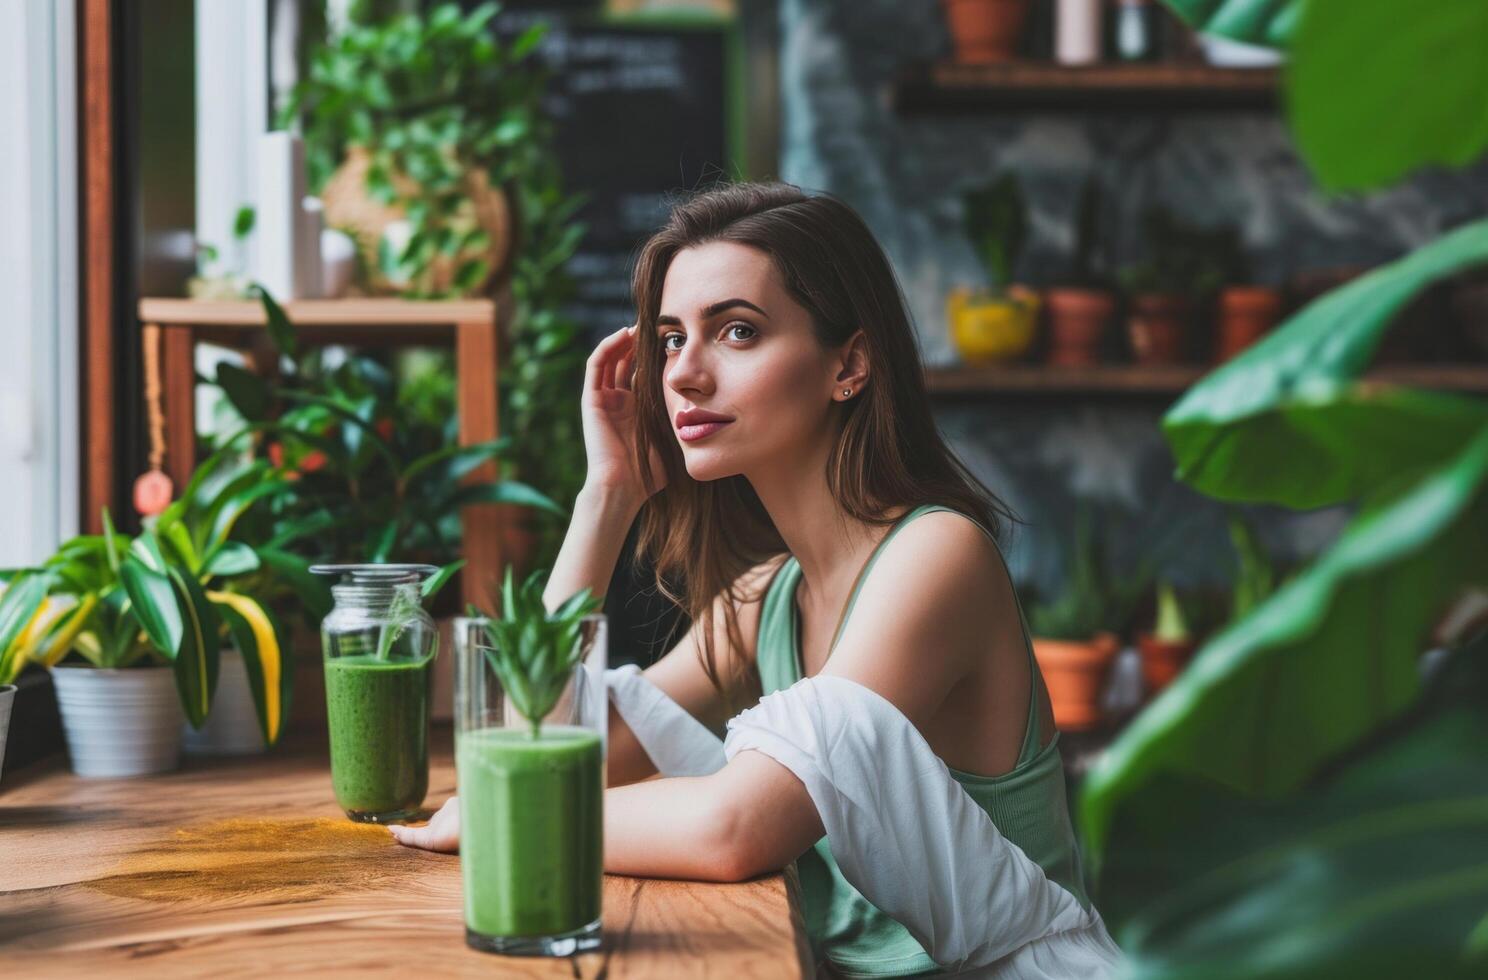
52,666,185,778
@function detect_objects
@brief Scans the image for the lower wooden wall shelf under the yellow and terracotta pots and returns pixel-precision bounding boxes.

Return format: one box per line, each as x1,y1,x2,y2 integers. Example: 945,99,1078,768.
926,364,1488,399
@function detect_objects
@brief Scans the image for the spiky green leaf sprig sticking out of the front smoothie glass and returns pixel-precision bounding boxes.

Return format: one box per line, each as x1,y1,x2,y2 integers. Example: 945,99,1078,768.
470,567,601,739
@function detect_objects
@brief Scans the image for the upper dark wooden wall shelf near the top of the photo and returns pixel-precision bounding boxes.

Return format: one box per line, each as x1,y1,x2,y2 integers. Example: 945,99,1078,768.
888,61,1278,115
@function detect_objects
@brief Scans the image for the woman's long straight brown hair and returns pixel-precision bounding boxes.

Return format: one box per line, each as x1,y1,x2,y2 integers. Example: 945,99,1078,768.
632,183,1015,693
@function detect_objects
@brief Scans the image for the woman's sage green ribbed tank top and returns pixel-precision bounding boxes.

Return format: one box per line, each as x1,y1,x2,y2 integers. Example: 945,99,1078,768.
757,504,1089,977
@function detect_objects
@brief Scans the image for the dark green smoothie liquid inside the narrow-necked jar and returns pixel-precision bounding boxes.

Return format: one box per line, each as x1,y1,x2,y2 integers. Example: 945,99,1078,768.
326,656,433,822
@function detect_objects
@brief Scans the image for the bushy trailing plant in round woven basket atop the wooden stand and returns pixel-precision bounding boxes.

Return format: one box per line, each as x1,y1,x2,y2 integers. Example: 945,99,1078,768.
281,3,588,564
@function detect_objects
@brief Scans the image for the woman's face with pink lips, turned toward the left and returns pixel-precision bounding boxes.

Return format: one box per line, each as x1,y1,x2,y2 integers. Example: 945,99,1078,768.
655,242,841,480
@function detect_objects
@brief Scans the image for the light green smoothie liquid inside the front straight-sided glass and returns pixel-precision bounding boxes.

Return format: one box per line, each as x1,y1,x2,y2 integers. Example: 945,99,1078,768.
455,726,604,937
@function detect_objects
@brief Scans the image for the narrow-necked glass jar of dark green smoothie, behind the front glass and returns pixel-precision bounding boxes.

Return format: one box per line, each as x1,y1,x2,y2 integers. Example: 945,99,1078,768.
314,565,439,824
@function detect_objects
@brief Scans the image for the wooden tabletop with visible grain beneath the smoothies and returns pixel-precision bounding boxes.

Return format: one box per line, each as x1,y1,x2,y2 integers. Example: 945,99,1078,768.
0,729,811,979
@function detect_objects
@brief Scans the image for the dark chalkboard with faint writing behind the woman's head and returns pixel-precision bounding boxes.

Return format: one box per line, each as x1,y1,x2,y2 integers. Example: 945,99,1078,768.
496,9,743,341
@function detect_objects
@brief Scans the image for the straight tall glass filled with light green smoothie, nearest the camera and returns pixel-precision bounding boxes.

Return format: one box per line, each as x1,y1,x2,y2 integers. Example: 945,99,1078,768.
454,613,609,956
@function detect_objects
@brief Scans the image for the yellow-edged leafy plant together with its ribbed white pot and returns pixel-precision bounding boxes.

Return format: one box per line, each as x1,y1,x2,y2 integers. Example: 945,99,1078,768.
0,493,305,775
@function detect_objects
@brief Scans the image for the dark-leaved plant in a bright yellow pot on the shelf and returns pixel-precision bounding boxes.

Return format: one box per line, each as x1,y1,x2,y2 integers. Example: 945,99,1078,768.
948,174,1039,364
